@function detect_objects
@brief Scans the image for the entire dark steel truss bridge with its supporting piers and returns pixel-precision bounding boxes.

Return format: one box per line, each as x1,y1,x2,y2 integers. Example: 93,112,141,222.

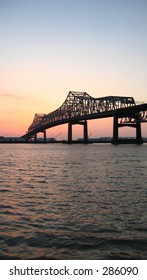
22,91,147,144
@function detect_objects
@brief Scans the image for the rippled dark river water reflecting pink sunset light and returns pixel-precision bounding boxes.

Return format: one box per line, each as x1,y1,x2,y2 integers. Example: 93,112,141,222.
0,144,147,259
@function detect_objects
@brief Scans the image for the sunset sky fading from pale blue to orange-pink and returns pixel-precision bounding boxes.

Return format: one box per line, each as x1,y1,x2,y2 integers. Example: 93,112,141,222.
0,0,147,139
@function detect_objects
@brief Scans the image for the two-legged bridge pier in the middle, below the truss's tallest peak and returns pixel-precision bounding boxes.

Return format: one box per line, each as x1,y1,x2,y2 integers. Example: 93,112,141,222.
68,120,88,144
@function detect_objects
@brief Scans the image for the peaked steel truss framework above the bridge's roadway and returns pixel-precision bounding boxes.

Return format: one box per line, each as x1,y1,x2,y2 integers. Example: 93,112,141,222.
28,91,135,133
